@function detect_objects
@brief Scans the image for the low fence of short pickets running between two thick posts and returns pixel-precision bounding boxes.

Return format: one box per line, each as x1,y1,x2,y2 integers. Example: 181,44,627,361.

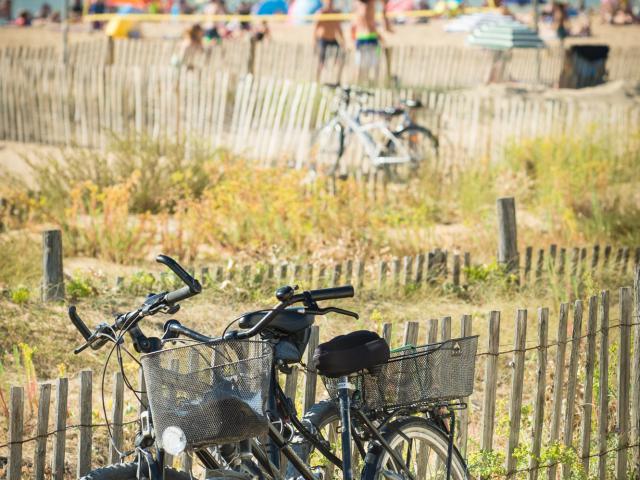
116,245,640,294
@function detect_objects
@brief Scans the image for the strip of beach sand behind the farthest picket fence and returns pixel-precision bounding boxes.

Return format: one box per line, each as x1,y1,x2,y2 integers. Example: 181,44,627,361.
0,17,640,46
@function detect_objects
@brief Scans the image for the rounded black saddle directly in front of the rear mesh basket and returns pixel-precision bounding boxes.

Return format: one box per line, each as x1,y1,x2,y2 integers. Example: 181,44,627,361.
313,330,389,378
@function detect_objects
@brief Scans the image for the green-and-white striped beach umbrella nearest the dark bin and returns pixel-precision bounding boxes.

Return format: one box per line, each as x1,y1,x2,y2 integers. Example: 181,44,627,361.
467,20,544,50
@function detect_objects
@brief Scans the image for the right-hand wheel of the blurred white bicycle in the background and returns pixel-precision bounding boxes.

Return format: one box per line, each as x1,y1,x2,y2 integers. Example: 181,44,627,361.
384,125,439,182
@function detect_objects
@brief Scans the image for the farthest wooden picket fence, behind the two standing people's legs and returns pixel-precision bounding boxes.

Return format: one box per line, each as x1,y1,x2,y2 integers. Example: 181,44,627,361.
0,38,640,89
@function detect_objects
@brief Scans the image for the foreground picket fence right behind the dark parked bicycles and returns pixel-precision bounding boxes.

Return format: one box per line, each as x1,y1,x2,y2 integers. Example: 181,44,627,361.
2,268,640,480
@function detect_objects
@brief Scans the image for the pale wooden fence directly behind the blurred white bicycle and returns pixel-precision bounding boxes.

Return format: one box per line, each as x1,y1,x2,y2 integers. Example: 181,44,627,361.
0,60,640,171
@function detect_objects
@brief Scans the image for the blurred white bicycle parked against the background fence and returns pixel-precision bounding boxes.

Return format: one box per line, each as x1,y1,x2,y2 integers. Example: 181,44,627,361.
311,84,439,182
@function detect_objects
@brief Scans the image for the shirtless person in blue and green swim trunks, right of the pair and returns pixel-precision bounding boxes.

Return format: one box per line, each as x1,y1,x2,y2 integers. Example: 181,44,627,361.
351,0,392,81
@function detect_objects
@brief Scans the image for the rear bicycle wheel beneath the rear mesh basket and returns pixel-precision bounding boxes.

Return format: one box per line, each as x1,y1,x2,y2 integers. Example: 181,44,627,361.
362,417,468,480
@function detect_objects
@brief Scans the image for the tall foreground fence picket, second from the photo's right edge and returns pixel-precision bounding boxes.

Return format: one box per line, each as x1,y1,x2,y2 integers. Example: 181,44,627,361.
616,287,632,478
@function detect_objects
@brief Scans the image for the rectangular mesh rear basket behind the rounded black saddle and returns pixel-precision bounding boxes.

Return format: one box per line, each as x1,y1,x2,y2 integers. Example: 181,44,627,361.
323,336,478,410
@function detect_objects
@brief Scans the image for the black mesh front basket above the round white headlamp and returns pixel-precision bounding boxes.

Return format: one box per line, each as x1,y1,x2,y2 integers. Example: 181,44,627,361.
141,340,273,447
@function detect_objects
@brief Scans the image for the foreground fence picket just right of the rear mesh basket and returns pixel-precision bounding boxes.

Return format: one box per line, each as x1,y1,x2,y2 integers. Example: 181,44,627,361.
480,311,500,451
